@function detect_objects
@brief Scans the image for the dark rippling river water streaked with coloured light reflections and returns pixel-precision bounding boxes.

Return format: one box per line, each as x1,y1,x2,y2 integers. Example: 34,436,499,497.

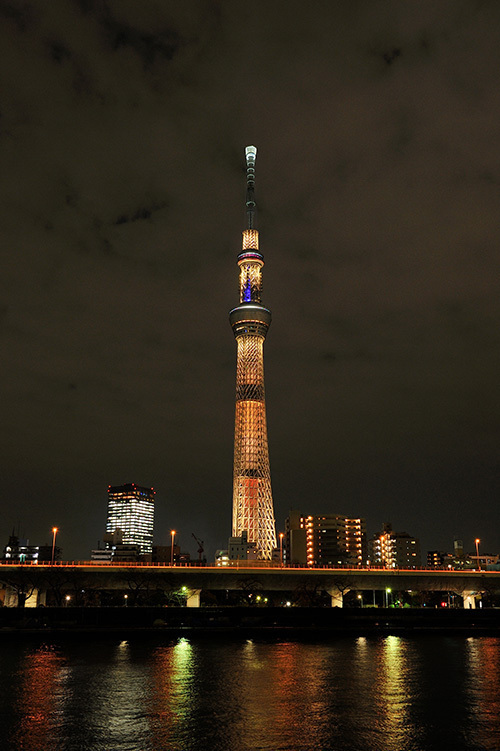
0,636,500,751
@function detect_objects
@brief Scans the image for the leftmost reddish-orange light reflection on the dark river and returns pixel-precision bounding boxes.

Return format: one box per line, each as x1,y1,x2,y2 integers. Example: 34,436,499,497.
13,646,64,751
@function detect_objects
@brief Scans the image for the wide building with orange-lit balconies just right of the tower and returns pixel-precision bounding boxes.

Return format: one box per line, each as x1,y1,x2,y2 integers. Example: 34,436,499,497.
285,511,367,567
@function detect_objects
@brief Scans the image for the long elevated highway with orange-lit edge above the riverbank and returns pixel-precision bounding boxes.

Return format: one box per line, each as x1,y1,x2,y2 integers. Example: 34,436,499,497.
0,561,500,608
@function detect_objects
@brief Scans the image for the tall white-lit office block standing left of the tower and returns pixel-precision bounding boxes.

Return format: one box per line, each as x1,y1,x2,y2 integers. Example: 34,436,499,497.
106,483,155,555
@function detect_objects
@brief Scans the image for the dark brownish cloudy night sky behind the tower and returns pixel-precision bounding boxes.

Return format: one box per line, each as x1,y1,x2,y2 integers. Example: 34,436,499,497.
0,0,500,559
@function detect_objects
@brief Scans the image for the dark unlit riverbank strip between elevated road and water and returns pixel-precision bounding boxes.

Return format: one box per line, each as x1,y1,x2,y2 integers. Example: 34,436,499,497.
0,606,500,638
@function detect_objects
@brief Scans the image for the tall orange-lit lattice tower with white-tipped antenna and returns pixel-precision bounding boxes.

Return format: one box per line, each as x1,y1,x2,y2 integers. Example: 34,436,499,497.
229,146,276,560
